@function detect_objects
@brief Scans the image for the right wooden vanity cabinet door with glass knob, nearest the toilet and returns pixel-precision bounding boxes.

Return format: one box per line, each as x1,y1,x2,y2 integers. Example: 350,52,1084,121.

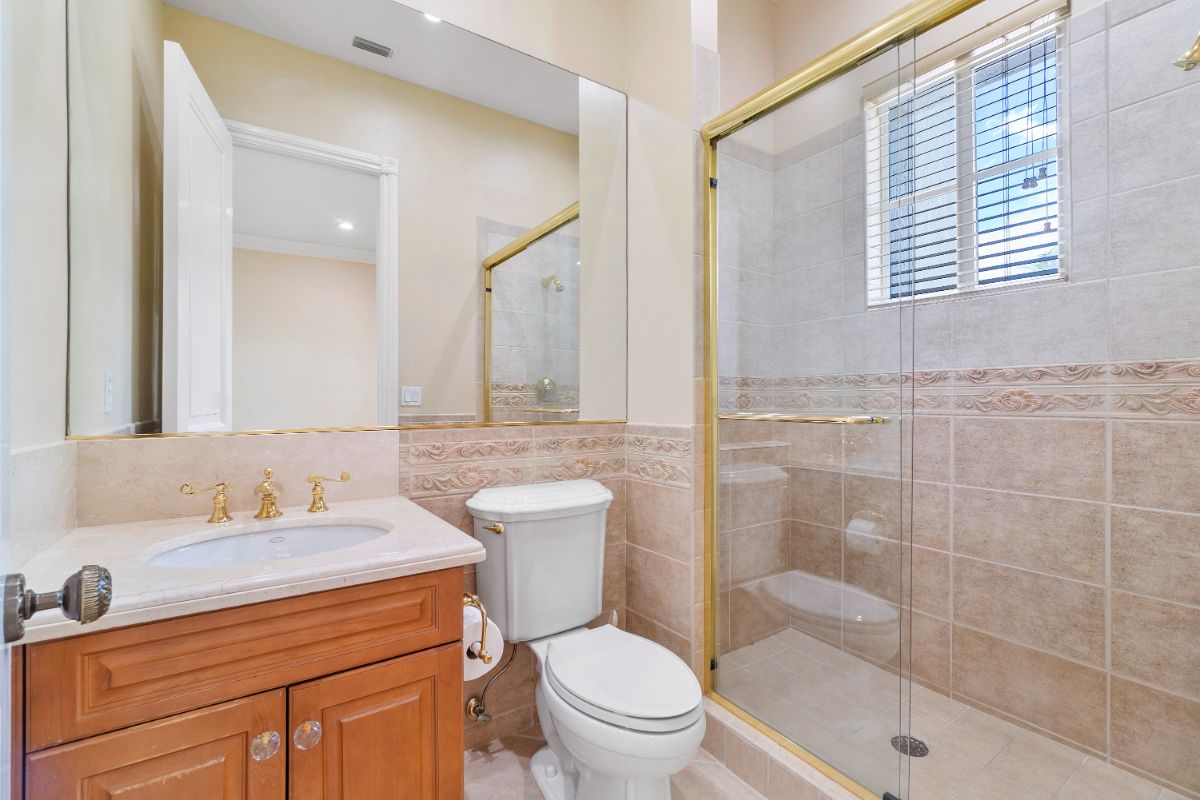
288,643,463,800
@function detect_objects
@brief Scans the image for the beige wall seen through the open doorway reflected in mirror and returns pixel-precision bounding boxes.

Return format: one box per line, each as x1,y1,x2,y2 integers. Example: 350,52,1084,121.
233,248,369,431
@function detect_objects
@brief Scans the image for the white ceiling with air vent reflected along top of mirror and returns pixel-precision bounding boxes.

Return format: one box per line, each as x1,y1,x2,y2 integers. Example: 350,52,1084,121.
166,0,580,134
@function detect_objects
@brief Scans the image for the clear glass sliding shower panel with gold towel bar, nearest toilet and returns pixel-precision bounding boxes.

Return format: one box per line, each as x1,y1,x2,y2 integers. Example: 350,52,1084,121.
713,34,913,798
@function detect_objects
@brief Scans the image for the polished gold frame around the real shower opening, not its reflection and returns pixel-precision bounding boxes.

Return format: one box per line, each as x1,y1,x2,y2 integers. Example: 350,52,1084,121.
700,0,983,800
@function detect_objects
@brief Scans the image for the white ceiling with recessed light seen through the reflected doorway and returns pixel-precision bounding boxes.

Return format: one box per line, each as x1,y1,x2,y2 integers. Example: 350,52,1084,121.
233,148,379,260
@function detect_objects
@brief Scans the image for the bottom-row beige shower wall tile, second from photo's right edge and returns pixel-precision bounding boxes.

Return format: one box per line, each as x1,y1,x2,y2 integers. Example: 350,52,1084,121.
952,625,1106,750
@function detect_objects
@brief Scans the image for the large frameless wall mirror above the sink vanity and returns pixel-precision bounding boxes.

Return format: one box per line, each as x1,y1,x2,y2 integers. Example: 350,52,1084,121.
67,0,626,437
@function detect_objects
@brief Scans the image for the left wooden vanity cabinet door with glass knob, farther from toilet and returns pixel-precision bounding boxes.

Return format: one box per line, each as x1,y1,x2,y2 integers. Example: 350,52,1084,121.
25,690,287,800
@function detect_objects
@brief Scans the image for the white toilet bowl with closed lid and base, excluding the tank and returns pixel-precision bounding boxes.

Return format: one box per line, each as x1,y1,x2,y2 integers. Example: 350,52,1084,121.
529,625,704,800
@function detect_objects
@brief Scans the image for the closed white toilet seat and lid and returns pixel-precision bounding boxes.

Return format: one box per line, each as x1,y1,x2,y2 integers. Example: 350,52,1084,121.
545,625,704,733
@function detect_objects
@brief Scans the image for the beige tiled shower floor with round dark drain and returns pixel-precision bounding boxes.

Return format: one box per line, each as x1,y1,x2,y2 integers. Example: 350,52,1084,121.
716,628,1186,800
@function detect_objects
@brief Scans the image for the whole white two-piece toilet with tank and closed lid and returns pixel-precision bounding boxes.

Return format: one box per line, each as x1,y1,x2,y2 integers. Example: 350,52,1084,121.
467,480,704,800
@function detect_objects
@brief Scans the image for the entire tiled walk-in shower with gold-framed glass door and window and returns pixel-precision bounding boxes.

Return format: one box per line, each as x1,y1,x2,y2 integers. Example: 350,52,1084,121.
702,0,1200,800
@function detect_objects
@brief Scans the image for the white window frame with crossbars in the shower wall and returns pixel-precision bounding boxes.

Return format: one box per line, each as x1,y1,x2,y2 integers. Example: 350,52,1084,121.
863,13,1069,308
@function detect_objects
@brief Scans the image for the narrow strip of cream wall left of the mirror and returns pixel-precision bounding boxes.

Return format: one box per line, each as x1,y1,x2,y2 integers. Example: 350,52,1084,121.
8,0,67,447
